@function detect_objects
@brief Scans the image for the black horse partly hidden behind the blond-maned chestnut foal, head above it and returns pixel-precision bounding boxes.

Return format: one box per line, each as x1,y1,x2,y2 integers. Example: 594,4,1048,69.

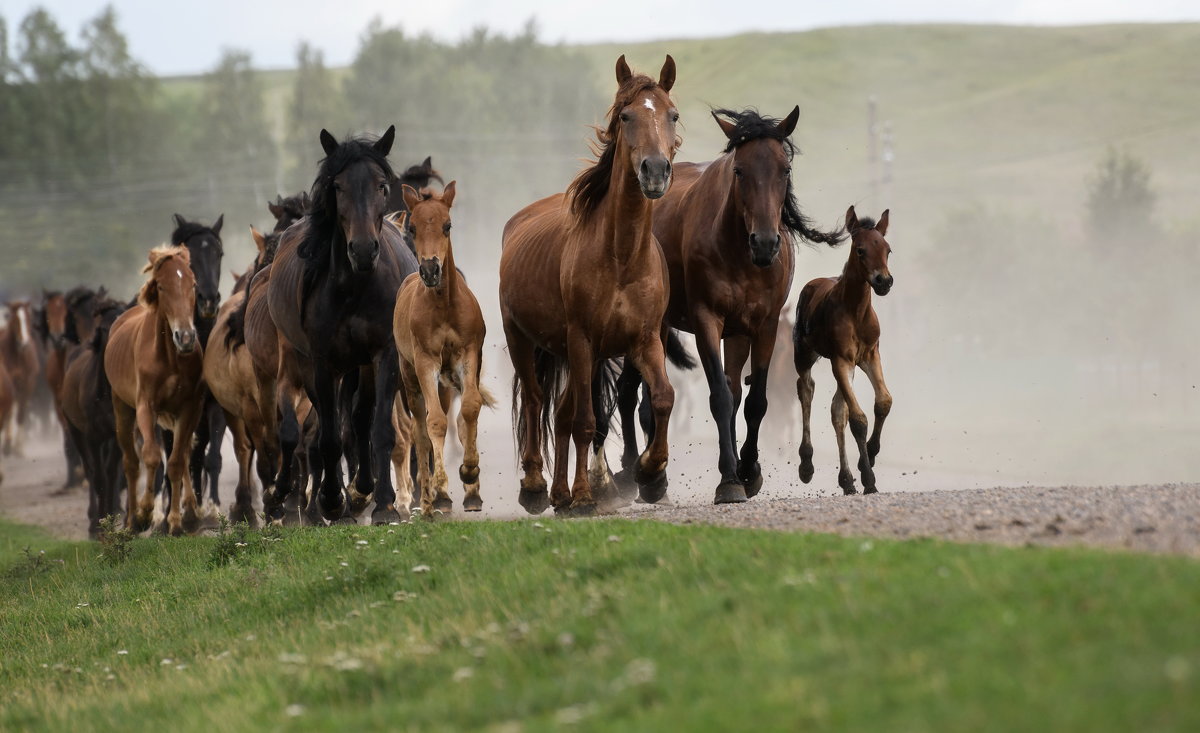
172,214,226,519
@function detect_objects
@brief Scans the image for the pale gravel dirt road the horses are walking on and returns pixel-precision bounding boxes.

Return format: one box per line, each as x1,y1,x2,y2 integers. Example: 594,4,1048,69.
0,440,1200,557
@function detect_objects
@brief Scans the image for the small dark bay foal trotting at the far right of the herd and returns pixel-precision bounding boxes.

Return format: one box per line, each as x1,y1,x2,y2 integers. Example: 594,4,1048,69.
792,206,894,494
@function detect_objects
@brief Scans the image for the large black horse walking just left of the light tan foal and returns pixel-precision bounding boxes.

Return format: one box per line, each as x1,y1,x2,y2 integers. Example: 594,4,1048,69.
263,126,416,523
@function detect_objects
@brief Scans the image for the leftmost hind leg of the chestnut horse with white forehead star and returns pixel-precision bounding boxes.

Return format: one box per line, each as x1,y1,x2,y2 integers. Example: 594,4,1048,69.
501,322,550,515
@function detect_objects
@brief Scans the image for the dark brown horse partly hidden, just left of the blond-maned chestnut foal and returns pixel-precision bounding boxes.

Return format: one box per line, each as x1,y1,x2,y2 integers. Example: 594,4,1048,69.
61,296,125,537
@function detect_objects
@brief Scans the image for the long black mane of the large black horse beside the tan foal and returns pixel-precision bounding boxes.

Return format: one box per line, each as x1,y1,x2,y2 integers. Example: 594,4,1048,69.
296,137,396,269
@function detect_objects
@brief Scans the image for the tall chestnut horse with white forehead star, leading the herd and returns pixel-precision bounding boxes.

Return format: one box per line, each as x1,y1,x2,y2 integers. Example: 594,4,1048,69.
500,56,679,513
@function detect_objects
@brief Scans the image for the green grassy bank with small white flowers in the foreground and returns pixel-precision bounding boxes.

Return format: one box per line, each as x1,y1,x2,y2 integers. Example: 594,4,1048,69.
0,519,1200,731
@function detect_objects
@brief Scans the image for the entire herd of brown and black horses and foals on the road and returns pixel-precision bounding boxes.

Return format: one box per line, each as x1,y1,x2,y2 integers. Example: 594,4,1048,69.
0,56,893,535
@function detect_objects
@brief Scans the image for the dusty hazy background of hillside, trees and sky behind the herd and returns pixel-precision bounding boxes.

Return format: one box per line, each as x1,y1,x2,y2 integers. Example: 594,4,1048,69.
0,0,1200,498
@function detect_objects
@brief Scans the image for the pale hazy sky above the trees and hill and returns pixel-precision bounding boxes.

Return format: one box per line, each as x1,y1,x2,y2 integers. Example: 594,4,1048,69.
7,0,1200,74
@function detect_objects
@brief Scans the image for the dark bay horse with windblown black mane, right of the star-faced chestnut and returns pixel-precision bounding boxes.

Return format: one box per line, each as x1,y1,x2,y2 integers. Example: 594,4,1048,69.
604,107,842,504
